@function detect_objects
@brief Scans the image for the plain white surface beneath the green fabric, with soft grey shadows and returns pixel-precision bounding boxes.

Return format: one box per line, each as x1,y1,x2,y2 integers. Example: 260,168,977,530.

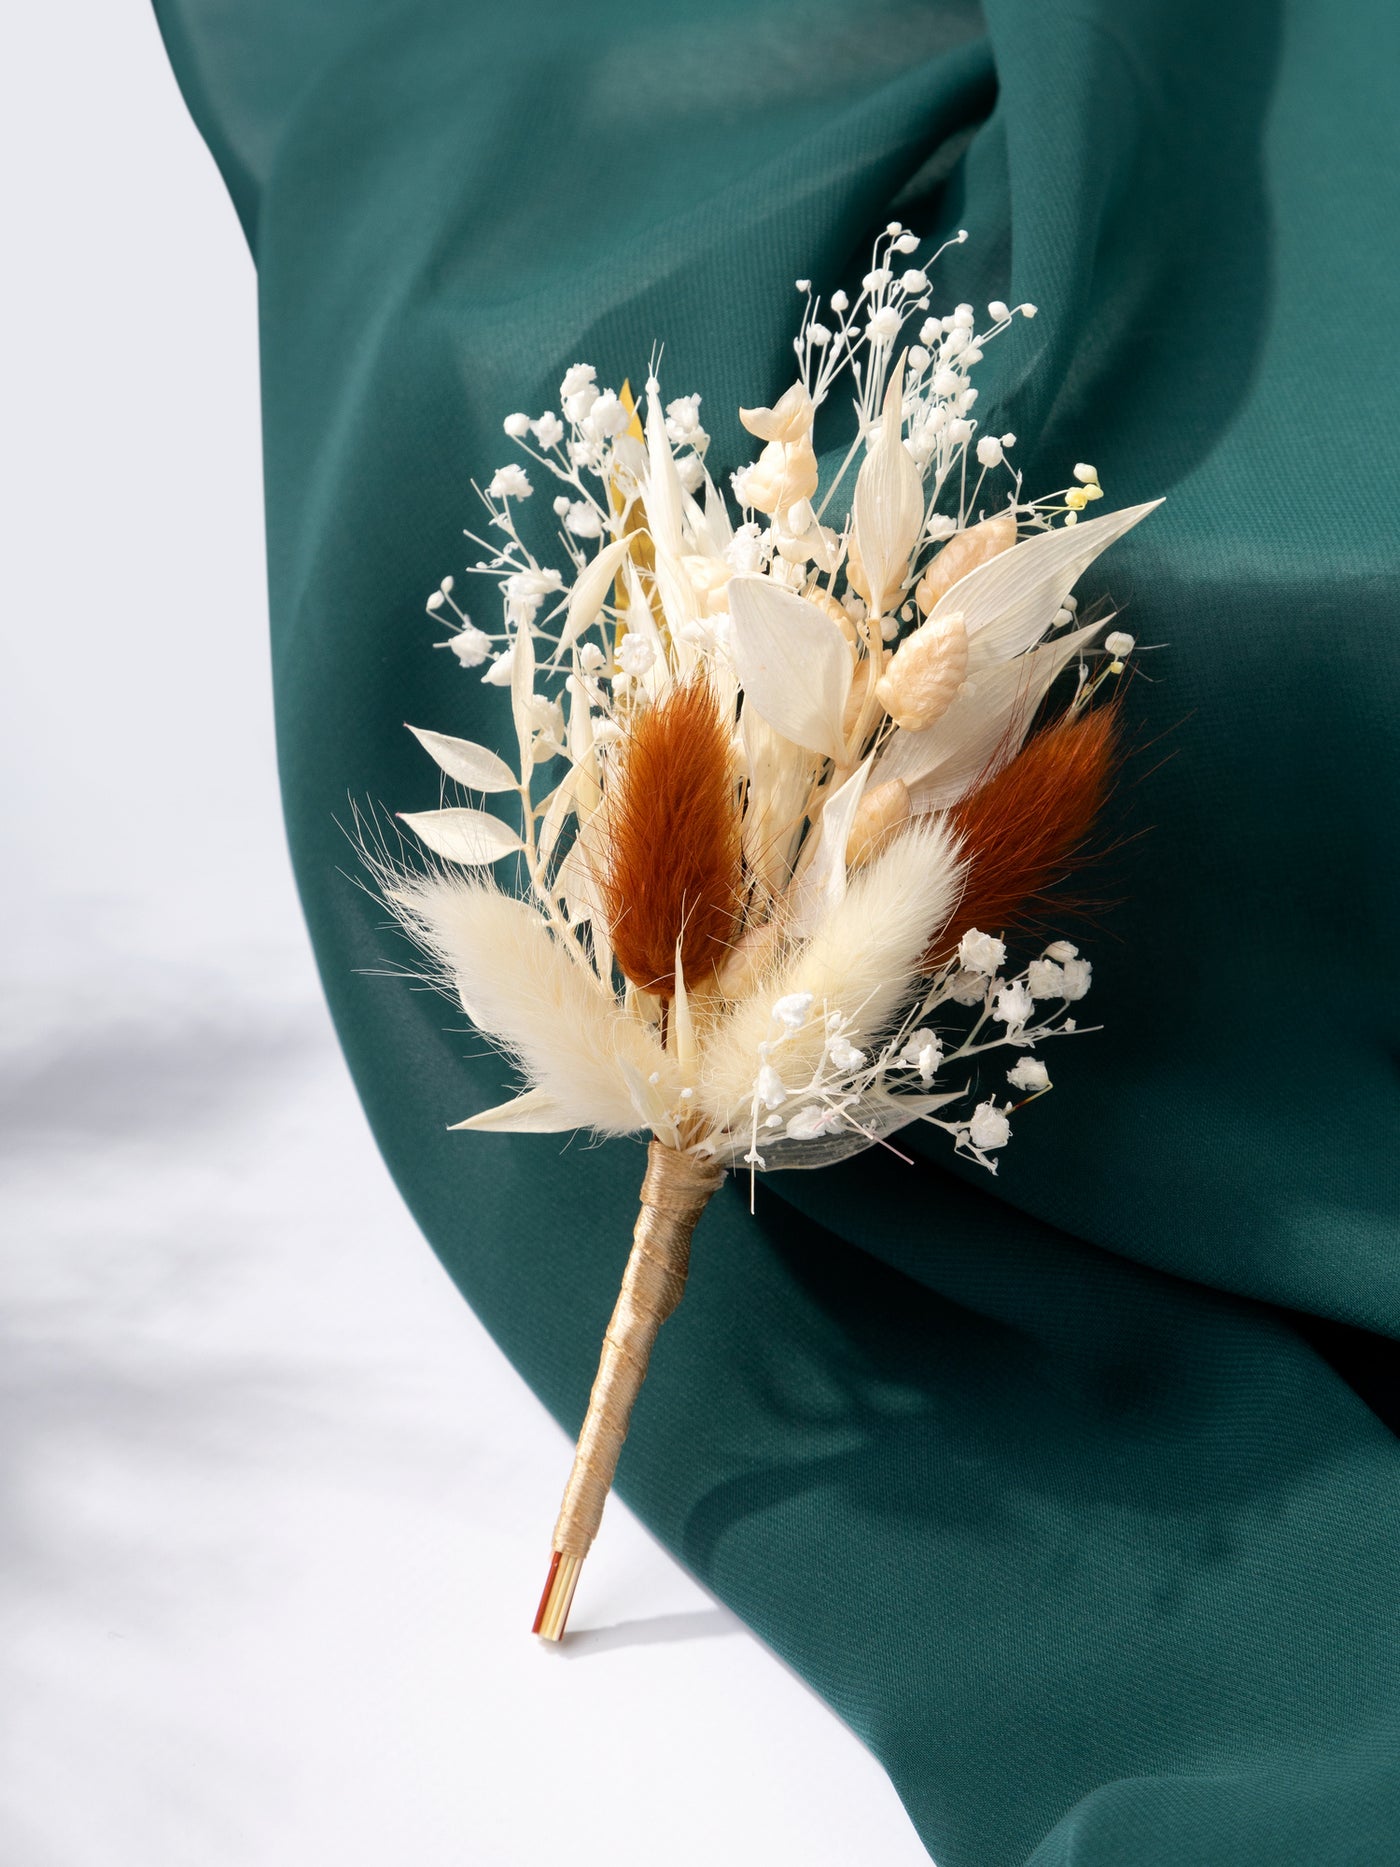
0,0,926,1867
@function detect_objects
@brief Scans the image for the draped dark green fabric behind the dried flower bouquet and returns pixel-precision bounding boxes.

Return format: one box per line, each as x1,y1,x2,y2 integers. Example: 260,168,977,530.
159,0,1400,1867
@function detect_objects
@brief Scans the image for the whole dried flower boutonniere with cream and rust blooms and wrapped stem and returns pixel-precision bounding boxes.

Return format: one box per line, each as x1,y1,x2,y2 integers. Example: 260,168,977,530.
375,222,1152,1639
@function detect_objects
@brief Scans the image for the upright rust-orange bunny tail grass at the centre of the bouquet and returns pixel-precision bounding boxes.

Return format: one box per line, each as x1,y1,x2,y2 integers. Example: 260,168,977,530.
597,680,743,997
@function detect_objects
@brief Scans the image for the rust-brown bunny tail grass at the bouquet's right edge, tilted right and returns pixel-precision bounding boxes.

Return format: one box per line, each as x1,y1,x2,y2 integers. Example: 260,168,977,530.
926,702,1118,971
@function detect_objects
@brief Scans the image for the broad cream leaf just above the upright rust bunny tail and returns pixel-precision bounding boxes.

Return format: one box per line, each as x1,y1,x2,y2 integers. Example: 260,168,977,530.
730,577,851,760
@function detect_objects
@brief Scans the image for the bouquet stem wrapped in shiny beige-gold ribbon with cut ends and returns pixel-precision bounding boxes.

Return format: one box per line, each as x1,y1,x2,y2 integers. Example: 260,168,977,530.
534,1141,724,1639
